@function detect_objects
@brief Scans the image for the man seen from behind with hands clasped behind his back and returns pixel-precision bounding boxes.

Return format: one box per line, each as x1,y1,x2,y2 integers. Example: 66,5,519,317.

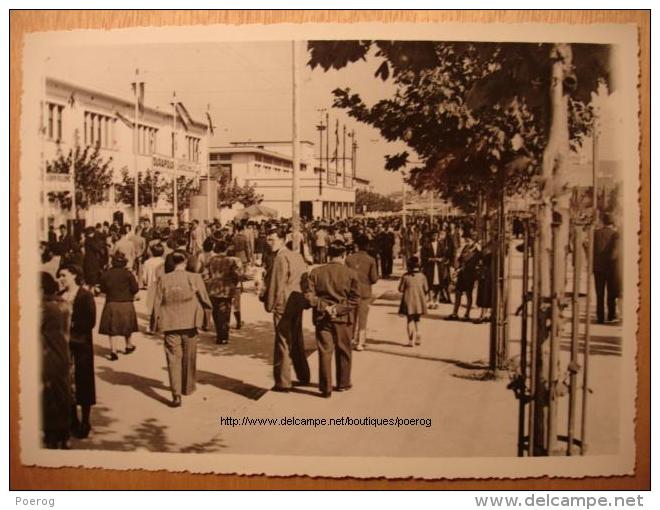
305,241,359,398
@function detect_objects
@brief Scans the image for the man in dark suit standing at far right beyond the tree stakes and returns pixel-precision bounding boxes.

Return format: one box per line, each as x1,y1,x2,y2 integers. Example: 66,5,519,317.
594,213,619,324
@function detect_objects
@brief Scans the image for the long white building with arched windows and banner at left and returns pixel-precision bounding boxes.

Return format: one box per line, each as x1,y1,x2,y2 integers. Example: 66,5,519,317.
42,78,208,232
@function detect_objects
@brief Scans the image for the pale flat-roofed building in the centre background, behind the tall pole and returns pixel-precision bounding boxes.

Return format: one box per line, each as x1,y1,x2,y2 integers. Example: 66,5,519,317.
209,141,364,219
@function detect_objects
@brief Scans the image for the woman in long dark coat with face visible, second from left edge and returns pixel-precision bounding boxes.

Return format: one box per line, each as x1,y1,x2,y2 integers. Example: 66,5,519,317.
57,265,96,438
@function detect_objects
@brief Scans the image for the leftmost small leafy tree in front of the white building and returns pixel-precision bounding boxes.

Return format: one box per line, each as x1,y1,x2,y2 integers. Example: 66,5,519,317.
46,140,113,215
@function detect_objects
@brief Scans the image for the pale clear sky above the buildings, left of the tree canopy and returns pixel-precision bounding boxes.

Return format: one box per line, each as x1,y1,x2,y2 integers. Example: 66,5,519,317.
43,41,406,193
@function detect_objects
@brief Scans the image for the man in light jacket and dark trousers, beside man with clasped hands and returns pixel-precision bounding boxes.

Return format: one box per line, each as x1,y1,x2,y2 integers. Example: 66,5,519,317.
264,228,309,392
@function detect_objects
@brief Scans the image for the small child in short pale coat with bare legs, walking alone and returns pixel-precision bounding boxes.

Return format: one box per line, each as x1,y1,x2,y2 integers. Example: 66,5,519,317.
399,256,429,347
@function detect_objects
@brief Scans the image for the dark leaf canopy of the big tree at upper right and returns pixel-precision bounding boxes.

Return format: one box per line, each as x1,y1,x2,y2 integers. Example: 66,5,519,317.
308,41,608,207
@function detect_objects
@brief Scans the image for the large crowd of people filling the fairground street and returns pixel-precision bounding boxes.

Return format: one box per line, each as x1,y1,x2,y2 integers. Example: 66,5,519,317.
41,209,613,448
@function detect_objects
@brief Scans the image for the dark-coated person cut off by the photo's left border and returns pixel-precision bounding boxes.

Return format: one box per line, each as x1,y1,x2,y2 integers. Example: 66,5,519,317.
40,271,72,449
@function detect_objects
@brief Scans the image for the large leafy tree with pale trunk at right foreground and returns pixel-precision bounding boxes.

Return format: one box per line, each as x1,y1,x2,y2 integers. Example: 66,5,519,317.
309,41,610,454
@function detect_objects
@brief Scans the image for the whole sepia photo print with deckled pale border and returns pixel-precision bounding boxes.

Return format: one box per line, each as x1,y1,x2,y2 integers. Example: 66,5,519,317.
18,20,639,479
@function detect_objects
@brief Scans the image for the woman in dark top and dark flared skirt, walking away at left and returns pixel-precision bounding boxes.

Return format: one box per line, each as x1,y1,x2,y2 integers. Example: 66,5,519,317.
99,251,139,361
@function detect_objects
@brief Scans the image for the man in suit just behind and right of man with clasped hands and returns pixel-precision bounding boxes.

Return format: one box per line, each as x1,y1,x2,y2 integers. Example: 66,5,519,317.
346,234,378,351
